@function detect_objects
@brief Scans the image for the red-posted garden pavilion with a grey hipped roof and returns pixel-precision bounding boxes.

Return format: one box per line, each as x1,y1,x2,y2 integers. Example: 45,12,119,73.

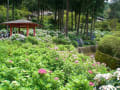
2,19,38,36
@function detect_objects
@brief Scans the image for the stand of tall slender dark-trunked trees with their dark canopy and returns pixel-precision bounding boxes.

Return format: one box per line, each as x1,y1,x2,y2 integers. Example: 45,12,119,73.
0,0,105,37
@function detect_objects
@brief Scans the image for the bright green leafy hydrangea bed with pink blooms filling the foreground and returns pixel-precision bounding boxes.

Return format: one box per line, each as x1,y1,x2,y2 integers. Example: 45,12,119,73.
0,37,107,90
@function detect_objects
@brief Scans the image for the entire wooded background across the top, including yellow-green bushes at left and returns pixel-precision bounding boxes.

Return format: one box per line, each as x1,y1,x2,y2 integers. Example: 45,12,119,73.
0,0,120,37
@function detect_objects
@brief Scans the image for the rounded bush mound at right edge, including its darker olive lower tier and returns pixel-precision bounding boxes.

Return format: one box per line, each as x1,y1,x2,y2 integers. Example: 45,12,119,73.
96,32,120,69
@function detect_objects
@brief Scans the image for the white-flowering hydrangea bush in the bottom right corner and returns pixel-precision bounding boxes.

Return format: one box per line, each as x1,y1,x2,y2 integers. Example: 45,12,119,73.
94,68,120,90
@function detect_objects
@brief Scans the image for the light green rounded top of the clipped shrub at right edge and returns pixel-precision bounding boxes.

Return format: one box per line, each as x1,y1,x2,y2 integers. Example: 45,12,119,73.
98,35,120,58
